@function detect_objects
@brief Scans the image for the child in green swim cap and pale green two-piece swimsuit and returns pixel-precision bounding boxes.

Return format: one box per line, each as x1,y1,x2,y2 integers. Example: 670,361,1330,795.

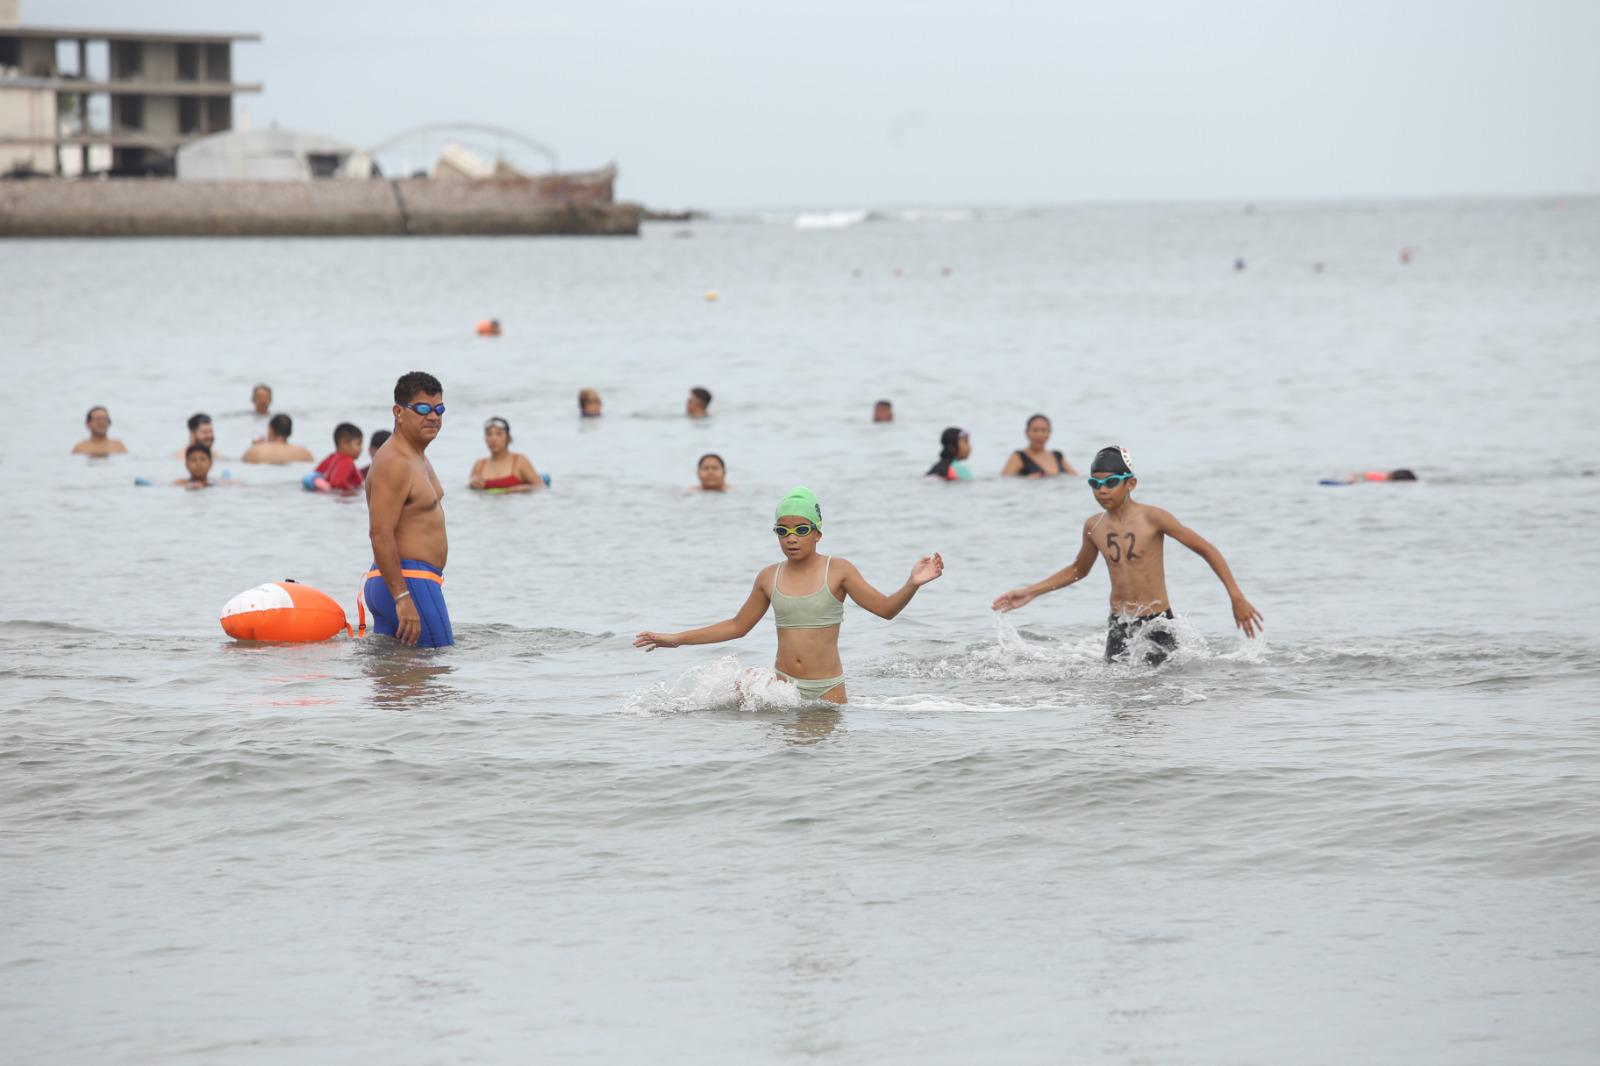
634,488,944,703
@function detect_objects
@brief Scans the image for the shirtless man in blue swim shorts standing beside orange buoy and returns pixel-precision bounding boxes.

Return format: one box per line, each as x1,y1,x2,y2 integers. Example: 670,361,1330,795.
363,370,456,648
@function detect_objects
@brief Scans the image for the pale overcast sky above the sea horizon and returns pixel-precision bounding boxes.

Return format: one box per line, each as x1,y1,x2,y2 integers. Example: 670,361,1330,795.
22,0,1600,208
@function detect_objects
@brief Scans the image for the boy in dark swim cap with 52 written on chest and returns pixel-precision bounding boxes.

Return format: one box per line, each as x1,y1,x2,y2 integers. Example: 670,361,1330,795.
994,445,1261,666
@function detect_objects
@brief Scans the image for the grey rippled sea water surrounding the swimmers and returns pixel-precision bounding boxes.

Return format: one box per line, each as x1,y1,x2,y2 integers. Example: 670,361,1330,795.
0,200,1600,1064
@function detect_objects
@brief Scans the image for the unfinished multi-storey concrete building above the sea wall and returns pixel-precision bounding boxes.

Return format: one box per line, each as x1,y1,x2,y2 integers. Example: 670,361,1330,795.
0,0,261,176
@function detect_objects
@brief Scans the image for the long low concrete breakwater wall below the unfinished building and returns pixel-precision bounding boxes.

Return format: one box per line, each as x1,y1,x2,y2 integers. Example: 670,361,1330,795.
0,178,642,237
